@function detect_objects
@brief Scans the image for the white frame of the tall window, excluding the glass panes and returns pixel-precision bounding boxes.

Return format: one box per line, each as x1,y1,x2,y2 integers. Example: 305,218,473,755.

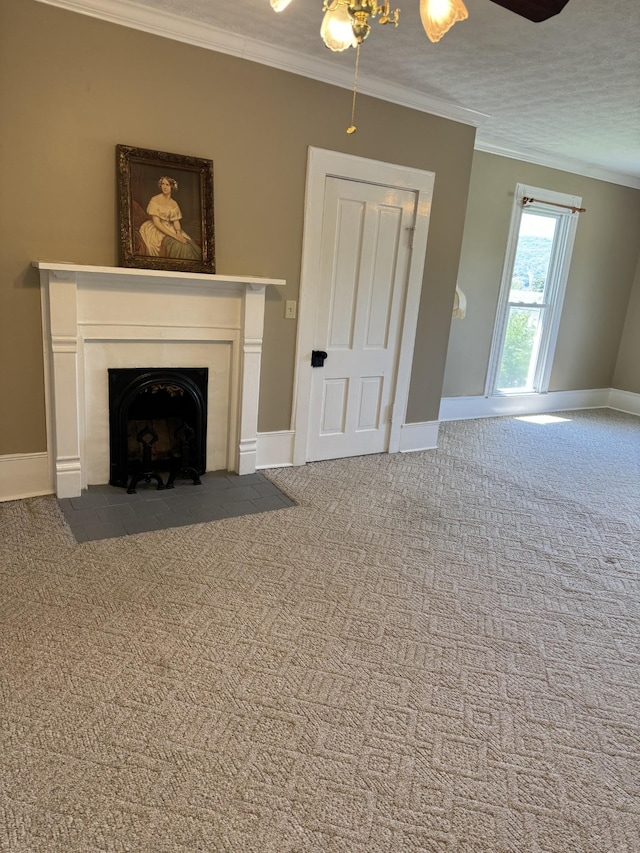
485,184,582,397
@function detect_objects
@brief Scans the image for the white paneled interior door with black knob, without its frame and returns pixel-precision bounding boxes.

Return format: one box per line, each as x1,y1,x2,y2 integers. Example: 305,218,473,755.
307,177,418,461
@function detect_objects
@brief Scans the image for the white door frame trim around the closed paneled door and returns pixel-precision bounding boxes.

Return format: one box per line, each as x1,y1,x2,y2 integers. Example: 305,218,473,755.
292,146,435,465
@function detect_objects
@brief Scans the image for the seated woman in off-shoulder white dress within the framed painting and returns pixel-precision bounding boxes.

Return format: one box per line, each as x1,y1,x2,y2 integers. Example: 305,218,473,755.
140,175,202,261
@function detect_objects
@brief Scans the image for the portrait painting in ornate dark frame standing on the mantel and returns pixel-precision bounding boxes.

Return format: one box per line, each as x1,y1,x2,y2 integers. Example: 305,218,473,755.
116,145,216,273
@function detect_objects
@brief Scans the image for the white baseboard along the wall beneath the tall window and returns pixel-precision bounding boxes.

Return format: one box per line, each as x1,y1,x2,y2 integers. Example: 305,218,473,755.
440,388,611,421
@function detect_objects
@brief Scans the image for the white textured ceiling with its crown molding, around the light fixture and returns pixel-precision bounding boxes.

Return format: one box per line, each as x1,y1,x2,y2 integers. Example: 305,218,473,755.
44,0,640,187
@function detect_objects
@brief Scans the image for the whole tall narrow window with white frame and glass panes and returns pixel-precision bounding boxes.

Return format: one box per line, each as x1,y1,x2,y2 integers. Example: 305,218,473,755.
486,184,582,396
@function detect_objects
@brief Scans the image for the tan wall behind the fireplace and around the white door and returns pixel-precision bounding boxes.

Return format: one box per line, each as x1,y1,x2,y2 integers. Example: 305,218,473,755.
0,0,475,455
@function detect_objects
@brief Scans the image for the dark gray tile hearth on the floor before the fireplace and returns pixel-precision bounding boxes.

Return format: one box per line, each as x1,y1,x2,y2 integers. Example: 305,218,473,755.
58,472,295,542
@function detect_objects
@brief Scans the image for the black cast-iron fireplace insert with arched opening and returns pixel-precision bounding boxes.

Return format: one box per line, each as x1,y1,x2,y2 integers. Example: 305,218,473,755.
109,367,209,493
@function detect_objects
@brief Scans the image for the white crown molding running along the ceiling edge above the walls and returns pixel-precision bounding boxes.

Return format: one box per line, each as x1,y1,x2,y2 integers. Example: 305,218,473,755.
36,0,640,189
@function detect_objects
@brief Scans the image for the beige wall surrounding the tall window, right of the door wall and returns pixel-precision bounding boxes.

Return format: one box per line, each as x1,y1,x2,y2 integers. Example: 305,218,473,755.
443,152,640,397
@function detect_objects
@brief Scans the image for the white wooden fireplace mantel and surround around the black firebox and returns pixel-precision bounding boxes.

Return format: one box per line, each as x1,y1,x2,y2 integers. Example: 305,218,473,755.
33,261,285,498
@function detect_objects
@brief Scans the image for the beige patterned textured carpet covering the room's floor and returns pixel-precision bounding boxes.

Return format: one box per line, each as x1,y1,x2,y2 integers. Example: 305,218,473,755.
0,410,640,853
